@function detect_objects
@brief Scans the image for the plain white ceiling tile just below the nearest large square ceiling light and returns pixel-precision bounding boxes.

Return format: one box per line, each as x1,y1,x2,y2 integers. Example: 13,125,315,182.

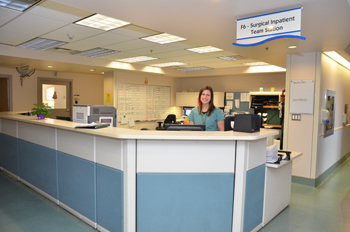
61,32,130,51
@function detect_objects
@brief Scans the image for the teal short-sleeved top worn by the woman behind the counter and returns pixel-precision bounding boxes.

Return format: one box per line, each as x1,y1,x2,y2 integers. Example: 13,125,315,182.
188,106,225,131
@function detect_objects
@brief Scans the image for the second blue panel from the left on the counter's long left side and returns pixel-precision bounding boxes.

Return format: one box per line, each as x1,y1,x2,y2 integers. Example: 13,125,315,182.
18,139,57,199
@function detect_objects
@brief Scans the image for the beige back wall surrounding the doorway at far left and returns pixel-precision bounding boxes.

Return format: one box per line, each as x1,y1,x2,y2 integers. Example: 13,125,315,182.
0,68,103,111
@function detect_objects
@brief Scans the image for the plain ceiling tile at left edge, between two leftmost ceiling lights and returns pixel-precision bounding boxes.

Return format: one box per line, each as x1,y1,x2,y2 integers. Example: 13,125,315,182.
1,14,67,37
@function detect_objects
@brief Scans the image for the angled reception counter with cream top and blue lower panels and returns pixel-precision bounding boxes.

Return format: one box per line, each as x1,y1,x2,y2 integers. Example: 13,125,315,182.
0,113,278,232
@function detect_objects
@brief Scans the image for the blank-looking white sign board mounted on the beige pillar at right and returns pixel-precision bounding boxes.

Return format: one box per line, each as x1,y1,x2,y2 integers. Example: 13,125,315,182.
289,80,315,114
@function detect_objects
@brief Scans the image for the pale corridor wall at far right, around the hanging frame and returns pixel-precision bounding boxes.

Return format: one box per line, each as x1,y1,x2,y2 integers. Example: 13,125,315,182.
316,54,350,177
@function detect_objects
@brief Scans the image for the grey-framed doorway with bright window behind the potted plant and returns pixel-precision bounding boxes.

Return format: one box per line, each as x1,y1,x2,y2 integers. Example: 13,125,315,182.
37,77,73,120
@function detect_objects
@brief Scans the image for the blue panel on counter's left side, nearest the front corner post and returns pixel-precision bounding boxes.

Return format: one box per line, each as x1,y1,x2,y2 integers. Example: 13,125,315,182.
96,164,124,232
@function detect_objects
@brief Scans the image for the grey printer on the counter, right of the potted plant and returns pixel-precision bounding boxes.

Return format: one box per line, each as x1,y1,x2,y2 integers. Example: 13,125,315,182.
73,105,117,127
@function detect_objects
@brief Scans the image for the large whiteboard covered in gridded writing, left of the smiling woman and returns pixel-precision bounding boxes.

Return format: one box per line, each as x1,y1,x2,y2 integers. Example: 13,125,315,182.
117,84,170,121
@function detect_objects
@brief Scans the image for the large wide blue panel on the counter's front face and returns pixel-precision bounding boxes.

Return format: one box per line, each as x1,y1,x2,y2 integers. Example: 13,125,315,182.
137,173,234,232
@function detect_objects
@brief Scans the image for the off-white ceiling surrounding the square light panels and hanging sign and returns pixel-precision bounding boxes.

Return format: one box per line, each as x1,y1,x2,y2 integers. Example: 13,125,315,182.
0,0,350,78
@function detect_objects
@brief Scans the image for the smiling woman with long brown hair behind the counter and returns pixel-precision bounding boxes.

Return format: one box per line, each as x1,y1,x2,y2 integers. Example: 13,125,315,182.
188,86,225,131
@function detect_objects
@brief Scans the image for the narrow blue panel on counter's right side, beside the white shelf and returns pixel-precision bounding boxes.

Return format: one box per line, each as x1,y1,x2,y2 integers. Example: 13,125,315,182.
243,164,265,232
